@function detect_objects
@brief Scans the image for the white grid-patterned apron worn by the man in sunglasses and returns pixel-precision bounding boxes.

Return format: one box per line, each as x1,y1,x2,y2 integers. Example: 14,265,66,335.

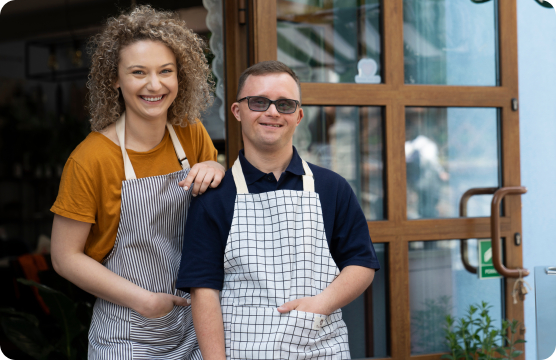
221,159,350,359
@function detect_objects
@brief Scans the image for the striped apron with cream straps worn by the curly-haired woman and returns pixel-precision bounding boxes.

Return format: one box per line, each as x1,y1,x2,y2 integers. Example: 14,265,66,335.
88,115,202,360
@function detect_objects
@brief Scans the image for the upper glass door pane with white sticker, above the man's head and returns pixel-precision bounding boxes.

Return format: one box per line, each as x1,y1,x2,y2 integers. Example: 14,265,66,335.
277,0,381,83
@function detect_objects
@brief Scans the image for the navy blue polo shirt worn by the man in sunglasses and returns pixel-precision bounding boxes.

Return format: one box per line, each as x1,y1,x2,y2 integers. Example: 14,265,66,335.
176,147,380,292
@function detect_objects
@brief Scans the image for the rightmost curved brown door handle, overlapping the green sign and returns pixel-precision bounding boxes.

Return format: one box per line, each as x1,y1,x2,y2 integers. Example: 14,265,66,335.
490,186,529,278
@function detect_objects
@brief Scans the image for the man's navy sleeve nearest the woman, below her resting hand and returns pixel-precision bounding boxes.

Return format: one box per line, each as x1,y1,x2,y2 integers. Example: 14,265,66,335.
176,197,224,292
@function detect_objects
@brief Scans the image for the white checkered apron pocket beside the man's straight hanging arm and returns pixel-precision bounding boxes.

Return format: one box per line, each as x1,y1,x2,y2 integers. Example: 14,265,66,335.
230,306,284,359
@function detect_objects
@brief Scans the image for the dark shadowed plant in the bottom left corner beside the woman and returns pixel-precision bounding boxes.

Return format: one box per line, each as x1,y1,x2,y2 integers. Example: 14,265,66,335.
0,279,92,360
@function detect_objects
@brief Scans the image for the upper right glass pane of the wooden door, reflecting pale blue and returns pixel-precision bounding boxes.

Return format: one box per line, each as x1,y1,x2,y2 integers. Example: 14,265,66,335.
403,0,498,86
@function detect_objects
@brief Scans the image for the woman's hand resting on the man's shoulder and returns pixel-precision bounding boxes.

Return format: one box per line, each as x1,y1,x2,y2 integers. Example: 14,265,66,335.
179,161,225,196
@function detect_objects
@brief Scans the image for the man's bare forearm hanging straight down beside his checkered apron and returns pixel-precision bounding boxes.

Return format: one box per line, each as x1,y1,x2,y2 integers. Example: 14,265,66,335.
191,288,226,360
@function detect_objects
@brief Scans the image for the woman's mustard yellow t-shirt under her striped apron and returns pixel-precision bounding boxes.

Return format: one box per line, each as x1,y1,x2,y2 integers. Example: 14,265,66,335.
50,123,218,262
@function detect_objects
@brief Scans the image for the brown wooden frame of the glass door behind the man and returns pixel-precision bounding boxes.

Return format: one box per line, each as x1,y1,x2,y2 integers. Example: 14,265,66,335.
224,0,525,360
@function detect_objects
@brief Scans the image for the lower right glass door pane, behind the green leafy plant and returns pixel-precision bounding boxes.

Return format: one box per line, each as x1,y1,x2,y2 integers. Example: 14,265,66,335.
409,239,503,355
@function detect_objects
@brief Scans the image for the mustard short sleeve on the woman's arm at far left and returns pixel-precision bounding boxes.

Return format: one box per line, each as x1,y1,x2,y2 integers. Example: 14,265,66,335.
50,157,97,224
